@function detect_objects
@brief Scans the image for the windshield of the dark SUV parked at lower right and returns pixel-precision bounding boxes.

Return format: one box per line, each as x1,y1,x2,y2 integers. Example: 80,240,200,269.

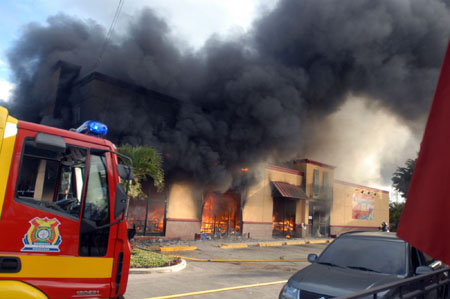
317,238,406,275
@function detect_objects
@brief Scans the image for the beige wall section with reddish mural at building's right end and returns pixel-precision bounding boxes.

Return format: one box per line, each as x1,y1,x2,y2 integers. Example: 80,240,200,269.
330,181,389,235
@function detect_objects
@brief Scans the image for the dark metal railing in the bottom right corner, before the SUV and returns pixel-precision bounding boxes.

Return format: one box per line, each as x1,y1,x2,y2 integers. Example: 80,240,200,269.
337,267,450,299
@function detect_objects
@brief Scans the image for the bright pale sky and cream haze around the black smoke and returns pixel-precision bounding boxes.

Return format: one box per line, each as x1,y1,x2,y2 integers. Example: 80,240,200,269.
0,0,436,197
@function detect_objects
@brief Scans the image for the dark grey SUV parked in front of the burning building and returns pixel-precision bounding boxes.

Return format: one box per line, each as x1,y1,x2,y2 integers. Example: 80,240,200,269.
279,232,442,299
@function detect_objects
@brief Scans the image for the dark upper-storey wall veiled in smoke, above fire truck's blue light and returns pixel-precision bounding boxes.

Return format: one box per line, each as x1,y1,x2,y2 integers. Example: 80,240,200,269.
69,73,178,144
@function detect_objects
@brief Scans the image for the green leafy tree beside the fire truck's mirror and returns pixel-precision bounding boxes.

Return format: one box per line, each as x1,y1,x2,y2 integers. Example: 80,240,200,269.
117,144,164,198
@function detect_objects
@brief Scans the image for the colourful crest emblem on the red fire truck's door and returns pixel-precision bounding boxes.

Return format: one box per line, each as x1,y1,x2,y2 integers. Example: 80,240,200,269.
21,217,62,252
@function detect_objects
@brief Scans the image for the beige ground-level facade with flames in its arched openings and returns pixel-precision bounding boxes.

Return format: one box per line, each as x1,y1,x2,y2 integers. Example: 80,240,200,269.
128,159,389,240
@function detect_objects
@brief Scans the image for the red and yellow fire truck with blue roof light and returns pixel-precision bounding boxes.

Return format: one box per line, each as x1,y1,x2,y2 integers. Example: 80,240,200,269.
0,107,132,299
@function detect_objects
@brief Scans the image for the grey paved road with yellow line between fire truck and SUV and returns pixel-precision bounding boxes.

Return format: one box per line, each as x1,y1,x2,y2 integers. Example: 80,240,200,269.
125,242,326,299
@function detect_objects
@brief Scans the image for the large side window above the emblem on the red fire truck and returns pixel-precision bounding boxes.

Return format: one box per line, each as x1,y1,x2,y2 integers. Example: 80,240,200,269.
16,138,87,219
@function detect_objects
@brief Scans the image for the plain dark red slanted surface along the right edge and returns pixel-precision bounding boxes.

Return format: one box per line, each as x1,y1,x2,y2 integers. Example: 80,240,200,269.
397,37,450,264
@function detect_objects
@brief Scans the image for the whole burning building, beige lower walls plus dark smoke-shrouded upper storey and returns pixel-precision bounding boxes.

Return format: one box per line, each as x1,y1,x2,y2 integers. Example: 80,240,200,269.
36,62,389,240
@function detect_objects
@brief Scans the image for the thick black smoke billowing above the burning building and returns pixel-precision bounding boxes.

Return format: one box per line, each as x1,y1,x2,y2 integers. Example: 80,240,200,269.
3,0,450,192
